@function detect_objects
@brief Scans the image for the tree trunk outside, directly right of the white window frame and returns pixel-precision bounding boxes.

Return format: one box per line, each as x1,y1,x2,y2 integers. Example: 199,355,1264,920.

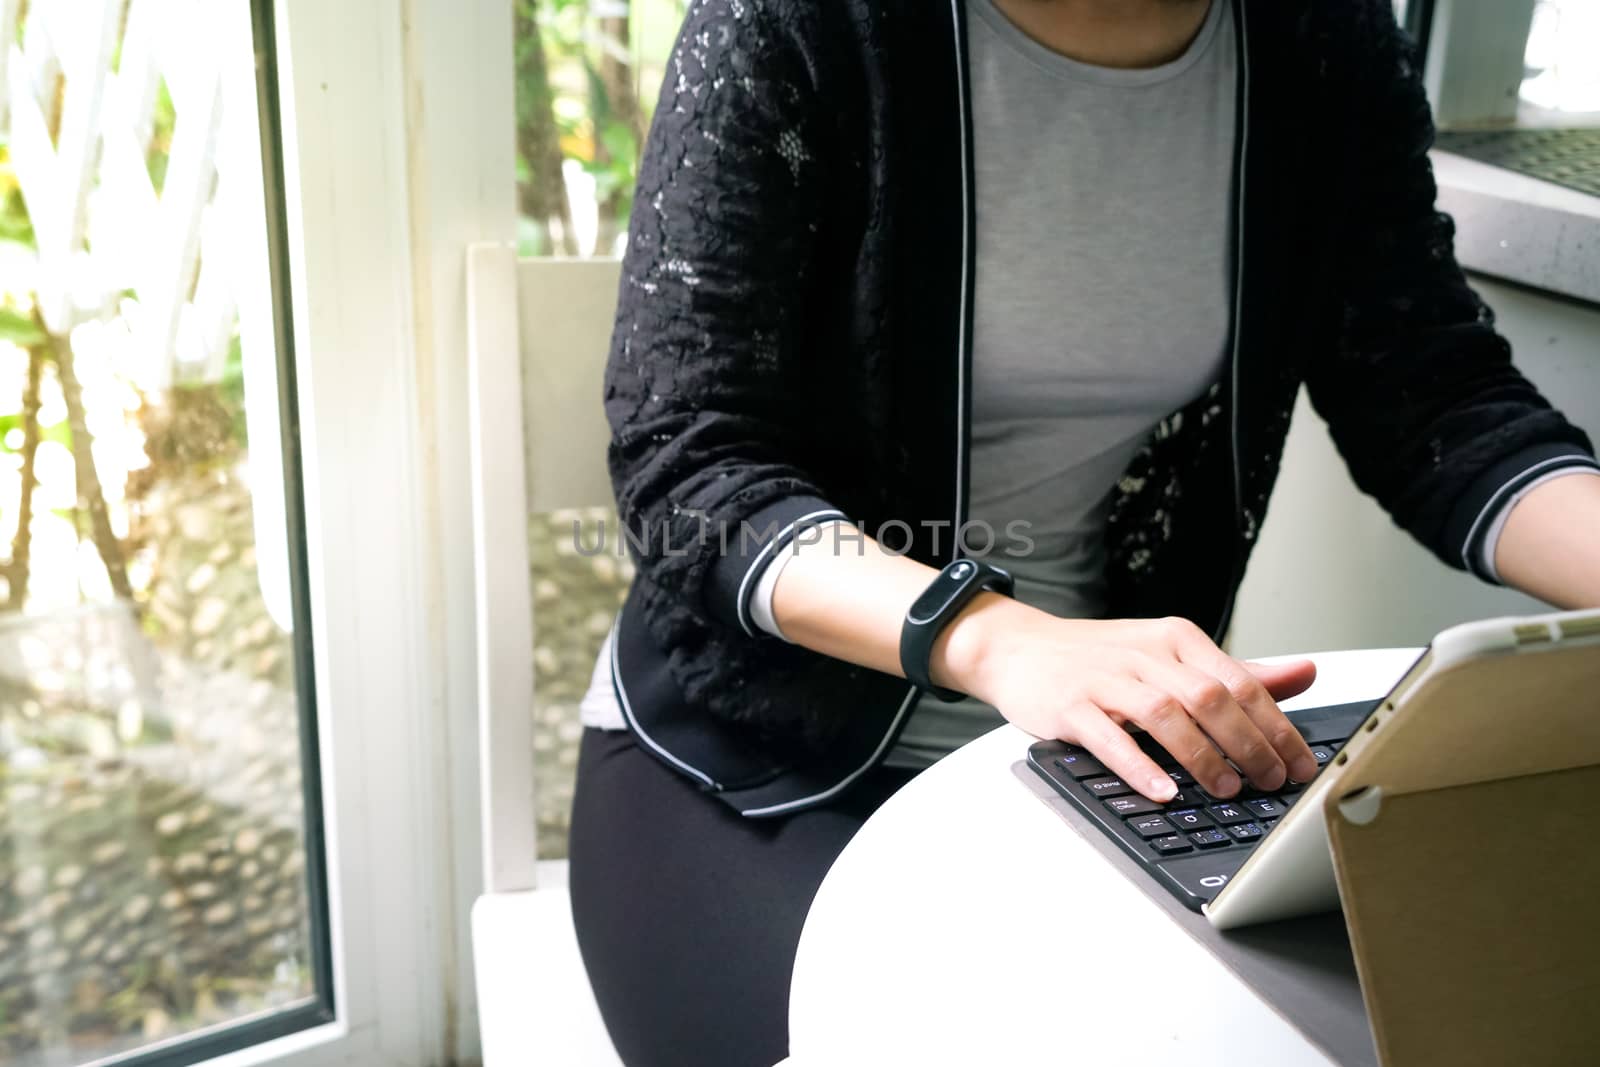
512,0,578,256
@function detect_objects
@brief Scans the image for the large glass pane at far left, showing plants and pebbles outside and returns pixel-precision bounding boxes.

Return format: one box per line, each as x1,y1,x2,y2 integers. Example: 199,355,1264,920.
0,0,328,1067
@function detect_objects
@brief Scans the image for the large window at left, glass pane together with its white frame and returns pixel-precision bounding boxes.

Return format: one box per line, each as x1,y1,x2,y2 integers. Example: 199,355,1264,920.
0,0,520,1067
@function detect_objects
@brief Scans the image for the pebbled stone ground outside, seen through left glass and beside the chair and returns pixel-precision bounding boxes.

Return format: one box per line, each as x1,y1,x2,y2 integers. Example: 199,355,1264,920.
0,502,617,1067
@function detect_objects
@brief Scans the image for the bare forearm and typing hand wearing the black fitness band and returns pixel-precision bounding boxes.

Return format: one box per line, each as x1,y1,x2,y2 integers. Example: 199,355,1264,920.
773,526,1317,800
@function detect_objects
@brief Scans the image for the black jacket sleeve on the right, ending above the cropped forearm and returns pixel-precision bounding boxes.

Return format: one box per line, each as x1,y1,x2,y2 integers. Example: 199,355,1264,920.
1306,0,1594,566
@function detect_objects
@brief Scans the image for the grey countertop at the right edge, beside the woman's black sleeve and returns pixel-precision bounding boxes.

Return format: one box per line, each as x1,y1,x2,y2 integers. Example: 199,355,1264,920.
1432,150,1600,304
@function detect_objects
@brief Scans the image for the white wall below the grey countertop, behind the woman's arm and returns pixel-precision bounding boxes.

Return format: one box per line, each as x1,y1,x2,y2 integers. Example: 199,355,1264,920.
1229,278,1600,656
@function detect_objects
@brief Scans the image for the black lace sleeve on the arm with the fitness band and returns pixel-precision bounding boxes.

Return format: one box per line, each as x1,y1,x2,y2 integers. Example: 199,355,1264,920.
605,0,864,726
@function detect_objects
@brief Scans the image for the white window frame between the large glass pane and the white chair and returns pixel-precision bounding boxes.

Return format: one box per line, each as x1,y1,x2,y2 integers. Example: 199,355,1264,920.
252,0,515,1067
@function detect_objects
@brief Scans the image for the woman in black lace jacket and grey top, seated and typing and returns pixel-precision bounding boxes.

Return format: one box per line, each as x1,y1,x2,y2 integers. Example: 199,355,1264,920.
571,0,1600,1065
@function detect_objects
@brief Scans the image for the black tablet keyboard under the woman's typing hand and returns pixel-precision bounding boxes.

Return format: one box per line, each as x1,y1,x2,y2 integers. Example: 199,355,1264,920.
1027,701,1379,912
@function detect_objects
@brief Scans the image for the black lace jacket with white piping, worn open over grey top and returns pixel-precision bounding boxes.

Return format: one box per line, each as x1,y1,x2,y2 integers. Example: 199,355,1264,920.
605,0,1589,814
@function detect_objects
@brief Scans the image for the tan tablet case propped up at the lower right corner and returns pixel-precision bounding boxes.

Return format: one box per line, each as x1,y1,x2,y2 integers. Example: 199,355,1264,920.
1325,625,1600,1067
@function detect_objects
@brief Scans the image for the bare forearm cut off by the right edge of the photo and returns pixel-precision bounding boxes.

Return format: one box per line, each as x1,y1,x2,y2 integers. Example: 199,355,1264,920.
1494,472,1600,608
